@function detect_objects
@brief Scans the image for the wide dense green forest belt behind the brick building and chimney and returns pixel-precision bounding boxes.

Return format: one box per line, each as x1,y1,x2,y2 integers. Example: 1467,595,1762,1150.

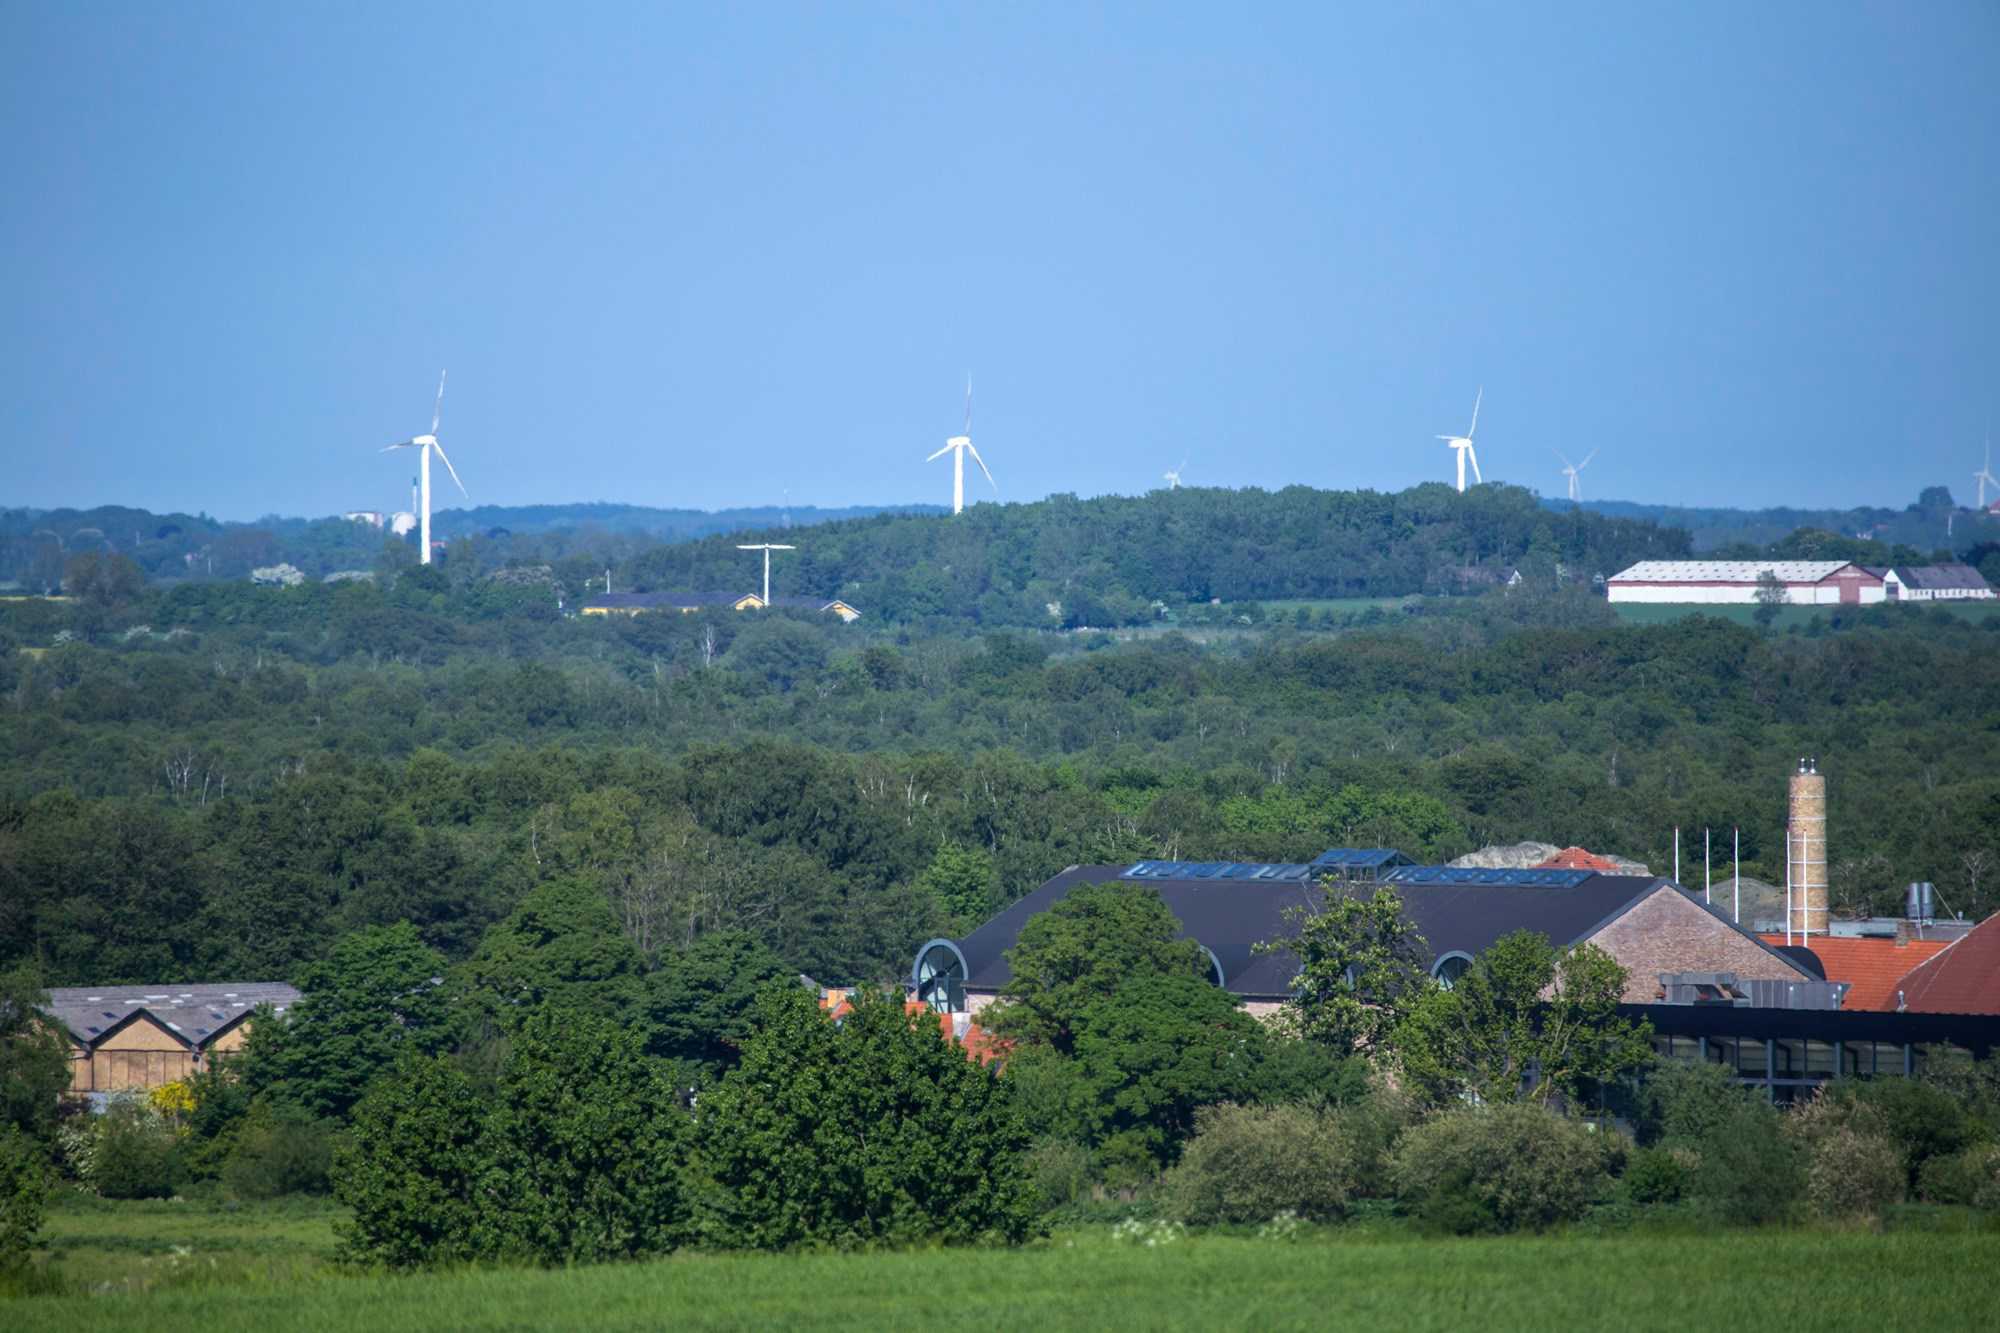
0,568,2000,983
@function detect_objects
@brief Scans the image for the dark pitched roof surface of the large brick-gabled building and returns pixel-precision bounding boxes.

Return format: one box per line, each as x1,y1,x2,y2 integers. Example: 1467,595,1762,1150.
958,865,1672,997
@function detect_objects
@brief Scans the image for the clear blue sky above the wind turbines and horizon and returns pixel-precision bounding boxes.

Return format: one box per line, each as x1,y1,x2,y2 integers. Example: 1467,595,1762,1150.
0,2,2000,518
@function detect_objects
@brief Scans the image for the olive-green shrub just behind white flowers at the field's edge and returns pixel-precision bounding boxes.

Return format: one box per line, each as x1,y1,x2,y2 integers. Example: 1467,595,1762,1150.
1162,1105,1354,1223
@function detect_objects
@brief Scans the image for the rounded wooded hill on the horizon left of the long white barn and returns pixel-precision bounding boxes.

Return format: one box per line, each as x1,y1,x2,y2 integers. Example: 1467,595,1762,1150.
624,484,1688,626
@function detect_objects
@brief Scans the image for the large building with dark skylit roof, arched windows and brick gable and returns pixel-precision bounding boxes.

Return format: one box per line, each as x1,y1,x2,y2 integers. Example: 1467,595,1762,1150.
910,847,1838,1015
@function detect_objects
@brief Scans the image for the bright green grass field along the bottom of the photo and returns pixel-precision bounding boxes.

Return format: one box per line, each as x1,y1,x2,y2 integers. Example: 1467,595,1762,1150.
0,1229,1996,1333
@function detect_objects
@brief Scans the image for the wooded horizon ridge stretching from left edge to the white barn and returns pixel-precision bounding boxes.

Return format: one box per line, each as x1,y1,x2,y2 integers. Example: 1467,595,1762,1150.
0,484,1688,628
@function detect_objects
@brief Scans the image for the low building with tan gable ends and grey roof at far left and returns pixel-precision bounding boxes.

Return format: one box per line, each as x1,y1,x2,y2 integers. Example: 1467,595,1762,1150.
48,981,298,1095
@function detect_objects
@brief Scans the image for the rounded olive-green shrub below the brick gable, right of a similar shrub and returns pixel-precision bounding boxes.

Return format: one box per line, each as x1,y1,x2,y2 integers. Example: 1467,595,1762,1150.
1392,1103,1618,1235
